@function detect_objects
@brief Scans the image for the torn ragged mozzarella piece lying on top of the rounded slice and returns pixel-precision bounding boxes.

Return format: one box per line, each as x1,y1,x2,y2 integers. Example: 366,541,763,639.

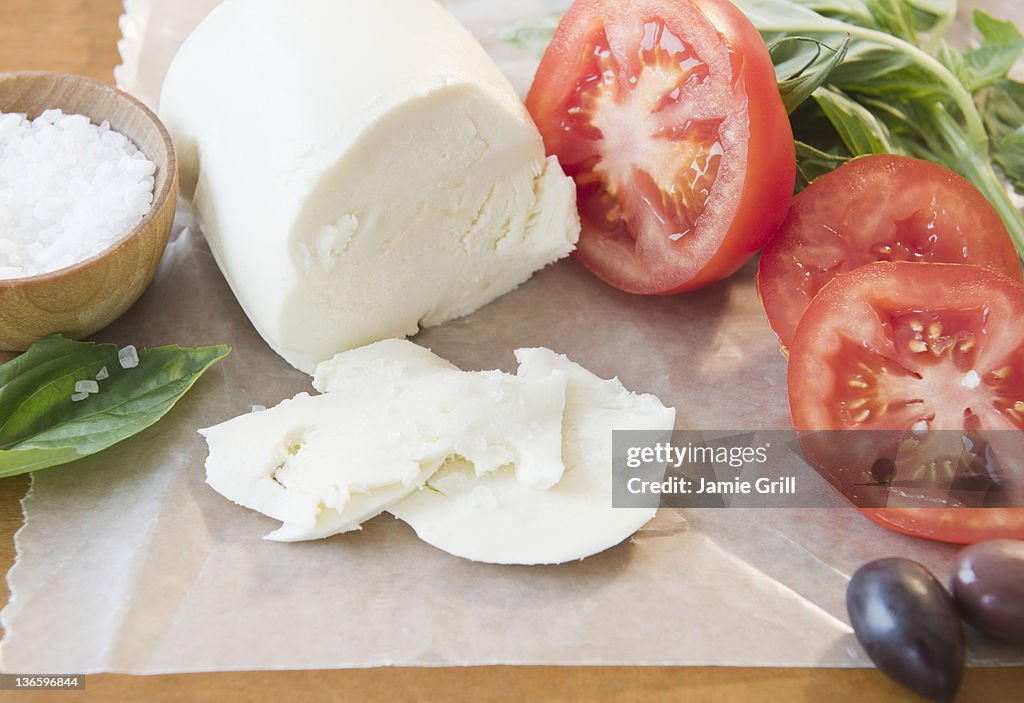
201,340,566,541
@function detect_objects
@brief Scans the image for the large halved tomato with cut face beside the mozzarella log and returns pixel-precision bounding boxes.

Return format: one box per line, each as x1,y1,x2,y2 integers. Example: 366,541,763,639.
526,0,796,294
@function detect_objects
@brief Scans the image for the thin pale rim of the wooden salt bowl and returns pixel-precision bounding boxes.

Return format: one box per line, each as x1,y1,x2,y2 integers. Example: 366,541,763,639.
0,71,178,289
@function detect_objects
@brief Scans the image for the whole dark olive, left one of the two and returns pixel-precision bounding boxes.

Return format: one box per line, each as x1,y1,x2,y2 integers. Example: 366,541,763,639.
846,559,964,701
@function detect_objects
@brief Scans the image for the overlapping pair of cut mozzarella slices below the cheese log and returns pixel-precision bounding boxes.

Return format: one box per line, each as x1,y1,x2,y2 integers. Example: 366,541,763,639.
201,340,675,564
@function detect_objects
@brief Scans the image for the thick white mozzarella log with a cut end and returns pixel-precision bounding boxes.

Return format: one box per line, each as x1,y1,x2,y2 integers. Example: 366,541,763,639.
160,0,580,372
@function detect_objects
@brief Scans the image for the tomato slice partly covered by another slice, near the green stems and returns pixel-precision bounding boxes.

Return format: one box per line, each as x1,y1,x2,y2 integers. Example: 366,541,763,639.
758,156,1022,347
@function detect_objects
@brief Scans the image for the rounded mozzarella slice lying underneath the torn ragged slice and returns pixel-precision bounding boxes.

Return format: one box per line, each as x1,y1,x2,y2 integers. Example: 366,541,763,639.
388,349,675,564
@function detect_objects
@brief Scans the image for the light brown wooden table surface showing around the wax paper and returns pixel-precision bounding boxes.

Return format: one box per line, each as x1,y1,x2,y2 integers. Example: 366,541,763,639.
0,0,1024,703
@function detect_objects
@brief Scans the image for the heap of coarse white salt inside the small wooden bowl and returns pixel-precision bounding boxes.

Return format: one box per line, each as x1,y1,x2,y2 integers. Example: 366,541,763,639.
0,109,157,278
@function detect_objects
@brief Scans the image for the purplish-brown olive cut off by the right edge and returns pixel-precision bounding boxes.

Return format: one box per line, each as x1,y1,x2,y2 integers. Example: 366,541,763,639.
952,539,1024,644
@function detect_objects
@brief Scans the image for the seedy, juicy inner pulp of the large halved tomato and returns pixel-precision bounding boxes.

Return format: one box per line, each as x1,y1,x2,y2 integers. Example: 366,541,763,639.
562,20,723,248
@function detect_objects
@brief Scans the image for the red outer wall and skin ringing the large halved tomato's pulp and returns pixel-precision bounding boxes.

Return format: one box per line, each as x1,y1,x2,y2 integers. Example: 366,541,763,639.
526,0,796,295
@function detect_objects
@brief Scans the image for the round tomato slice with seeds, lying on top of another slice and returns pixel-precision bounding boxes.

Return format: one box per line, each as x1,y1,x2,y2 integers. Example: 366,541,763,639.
788,262,1024,542
